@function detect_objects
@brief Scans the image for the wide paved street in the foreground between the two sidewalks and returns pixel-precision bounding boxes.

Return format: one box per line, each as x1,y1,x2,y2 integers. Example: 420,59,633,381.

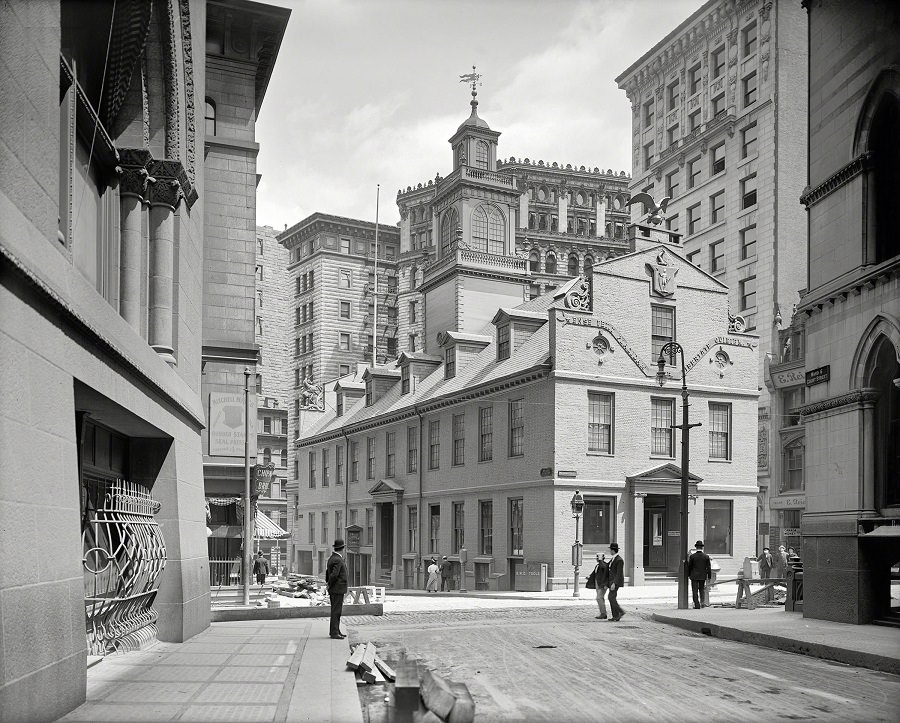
346,607,900,721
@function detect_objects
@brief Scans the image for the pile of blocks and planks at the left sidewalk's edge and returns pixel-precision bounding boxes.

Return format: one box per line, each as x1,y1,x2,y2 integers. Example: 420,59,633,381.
347,643,475,723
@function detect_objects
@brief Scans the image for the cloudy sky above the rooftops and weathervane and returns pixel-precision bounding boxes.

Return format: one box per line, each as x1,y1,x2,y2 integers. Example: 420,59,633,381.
256,0,703,230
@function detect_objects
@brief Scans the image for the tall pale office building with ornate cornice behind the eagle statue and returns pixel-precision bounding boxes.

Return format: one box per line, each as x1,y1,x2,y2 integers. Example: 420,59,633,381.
616,0,807,547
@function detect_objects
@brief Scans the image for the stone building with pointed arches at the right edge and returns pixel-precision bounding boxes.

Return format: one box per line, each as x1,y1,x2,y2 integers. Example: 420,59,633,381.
798,0,900,624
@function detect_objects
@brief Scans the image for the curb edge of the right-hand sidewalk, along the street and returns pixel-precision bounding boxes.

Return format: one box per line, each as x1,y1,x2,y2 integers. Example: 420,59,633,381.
650,613,900,675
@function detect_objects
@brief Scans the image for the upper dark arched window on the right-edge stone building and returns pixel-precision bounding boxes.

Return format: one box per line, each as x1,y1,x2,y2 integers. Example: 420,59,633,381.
869,93,900,264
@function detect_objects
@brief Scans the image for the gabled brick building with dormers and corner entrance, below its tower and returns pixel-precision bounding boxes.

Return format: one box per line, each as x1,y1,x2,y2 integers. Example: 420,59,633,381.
292,227,758,590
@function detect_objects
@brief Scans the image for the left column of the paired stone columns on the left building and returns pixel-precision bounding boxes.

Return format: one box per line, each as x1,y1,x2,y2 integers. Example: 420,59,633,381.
119,153,150,333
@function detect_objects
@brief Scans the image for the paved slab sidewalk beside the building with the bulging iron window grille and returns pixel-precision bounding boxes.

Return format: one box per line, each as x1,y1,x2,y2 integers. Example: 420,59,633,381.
61,618,363,723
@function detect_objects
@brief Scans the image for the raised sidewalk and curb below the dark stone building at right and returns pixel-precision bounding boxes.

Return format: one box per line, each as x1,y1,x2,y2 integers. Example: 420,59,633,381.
651,607,900,675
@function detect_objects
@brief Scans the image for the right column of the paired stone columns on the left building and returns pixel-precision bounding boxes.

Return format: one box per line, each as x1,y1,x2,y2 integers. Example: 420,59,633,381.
148,161,181,366
